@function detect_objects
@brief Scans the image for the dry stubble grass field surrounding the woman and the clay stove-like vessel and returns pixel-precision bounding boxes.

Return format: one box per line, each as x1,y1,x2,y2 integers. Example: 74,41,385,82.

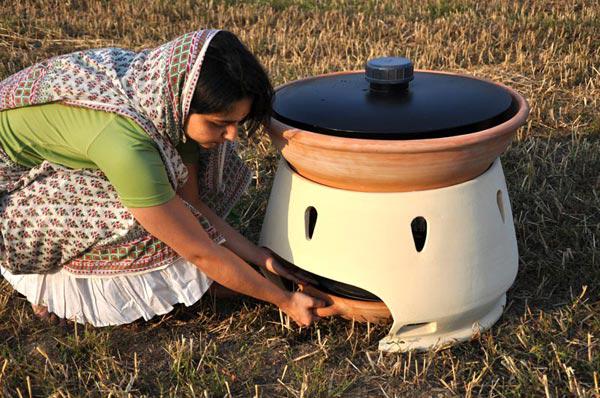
0,0,600,397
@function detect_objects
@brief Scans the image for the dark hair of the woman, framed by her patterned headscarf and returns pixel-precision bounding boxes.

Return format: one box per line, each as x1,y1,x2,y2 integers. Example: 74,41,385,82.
190,31,273,135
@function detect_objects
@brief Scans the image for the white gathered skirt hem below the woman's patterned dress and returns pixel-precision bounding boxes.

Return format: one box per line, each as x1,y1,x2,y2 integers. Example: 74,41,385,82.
0,257,212,327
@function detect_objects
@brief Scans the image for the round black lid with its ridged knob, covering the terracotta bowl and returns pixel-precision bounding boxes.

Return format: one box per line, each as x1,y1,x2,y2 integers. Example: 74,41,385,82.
273,57,516,139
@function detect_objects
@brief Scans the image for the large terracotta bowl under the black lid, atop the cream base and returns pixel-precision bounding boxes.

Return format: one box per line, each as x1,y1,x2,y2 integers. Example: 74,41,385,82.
267,71,529,192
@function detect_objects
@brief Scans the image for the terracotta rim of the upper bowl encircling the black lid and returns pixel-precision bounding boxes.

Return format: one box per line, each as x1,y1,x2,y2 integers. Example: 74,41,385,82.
267,70,529,153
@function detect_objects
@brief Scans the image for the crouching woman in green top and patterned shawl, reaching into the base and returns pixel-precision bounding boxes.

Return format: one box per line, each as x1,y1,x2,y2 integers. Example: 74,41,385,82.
0,30,324,326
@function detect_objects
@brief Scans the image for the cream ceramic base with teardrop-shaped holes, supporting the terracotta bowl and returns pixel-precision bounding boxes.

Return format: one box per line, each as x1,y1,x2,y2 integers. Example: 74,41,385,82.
260,160,518,351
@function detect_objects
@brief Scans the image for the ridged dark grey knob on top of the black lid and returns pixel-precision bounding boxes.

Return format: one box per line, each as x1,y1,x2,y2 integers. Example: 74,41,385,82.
365,57,414,86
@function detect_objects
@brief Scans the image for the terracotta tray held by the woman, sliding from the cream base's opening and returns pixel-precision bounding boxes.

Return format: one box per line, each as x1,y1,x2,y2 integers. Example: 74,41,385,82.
300,285,392,324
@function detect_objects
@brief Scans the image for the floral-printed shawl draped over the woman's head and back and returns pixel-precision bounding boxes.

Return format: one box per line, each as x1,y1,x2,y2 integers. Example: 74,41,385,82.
0,30,218,189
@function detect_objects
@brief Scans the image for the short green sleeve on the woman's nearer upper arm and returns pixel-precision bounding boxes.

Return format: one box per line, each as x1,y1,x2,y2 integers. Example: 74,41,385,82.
87,117,175,207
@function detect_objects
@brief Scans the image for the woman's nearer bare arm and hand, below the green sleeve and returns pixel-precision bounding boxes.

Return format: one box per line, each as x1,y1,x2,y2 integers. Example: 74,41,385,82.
129,196,324,326
